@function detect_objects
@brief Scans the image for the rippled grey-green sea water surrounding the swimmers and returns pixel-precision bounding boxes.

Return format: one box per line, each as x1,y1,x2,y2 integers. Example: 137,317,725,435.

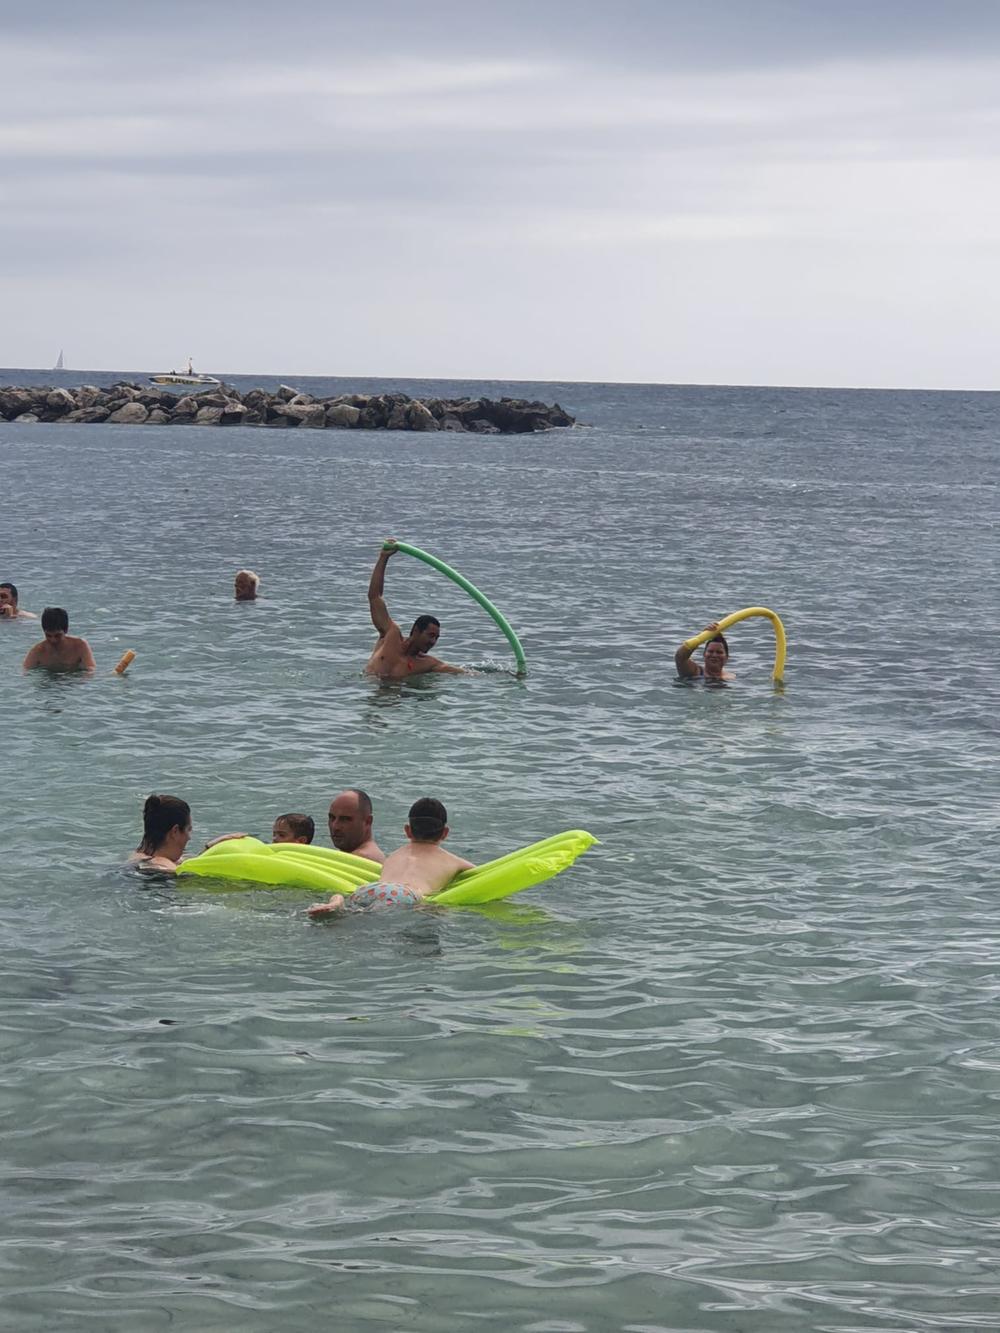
0,372,1000,1333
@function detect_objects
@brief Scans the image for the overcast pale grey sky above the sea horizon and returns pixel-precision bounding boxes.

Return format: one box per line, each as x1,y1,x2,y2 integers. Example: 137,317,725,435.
0,0,1000,389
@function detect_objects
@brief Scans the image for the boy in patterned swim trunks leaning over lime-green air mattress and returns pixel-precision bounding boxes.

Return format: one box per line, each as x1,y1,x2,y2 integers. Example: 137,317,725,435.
309,796,473,917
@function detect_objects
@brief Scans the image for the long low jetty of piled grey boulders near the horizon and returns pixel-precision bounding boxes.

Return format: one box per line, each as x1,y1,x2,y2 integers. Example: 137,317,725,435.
0,380,575,435
